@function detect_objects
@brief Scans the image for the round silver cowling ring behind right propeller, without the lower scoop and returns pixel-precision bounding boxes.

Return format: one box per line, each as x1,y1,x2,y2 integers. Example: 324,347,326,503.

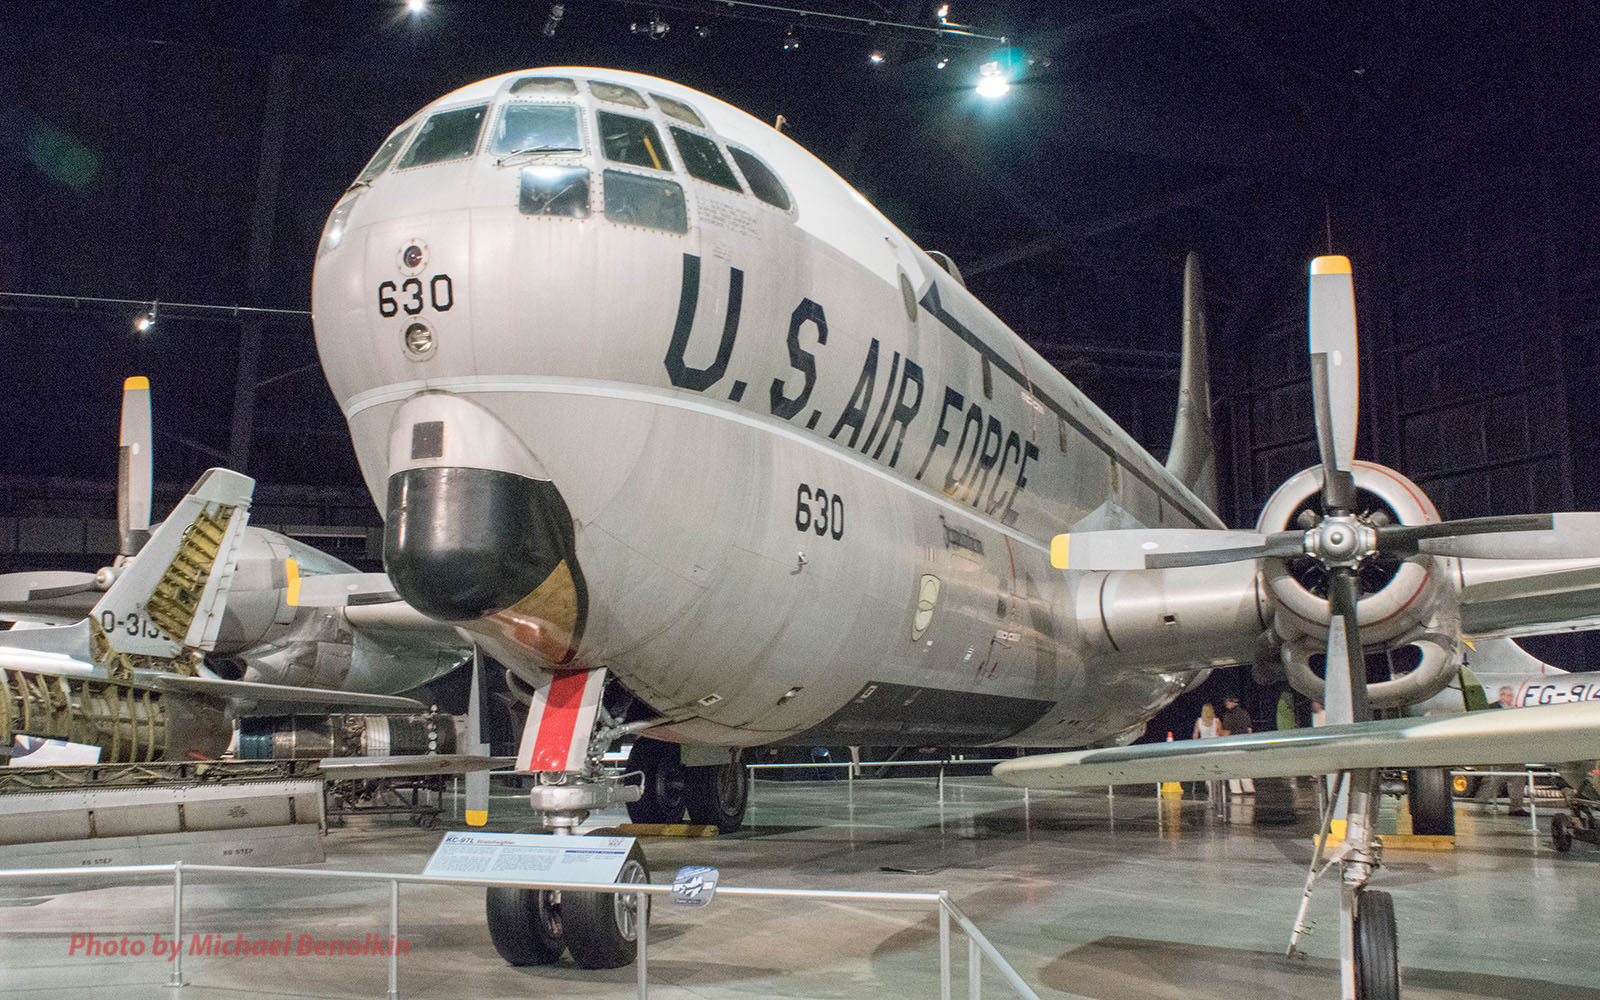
1256,462,1456,646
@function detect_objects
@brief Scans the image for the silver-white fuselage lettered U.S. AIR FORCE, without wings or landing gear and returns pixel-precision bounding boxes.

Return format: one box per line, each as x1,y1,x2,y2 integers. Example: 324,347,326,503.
314,67,1228,746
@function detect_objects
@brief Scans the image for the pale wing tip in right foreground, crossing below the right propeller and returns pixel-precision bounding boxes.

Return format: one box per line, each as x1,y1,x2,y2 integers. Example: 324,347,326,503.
995,701,1600,789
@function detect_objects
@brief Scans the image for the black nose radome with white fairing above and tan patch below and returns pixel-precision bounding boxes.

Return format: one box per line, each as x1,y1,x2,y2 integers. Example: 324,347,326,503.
384,395,587,664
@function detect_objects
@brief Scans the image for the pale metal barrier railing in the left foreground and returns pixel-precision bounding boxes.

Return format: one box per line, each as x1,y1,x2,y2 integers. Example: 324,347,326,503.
0,857,1038,1000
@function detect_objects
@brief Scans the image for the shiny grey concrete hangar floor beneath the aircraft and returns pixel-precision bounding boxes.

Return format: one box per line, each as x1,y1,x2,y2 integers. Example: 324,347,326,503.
0,778,1600,1000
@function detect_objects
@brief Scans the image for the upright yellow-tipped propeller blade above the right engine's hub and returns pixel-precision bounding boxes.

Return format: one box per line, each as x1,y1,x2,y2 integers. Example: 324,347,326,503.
1309,256,1360,512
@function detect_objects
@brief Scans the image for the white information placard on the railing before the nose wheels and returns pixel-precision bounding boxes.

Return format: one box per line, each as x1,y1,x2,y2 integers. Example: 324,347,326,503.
422,830,634,885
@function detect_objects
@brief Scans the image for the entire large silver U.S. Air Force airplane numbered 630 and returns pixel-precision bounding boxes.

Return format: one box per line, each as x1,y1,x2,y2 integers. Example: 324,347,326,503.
314,67,1600,995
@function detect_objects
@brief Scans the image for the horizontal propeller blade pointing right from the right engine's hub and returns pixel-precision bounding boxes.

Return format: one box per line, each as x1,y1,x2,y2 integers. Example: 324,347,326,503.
1378,510,1600,558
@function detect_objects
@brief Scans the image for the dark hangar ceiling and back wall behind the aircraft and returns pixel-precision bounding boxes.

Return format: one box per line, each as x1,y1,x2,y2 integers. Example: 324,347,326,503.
0,0,1600,563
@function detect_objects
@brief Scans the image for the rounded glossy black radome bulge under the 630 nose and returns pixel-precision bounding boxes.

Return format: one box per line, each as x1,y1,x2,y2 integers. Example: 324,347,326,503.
384,467,582,622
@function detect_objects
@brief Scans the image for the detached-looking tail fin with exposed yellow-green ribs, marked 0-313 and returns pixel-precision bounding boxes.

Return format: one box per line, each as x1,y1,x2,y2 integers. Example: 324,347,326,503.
90,469,256,658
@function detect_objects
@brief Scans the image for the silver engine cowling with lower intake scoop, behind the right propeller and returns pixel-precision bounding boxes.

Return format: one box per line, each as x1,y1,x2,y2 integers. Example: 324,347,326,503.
1258,461,1461,709
